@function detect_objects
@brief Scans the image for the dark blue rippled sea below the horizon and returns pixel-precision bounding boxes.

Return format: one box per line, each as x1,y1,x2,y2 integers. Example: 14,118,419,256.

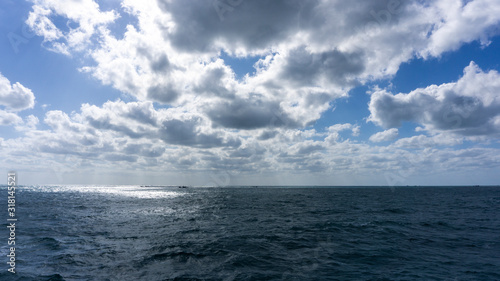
0,186,500,280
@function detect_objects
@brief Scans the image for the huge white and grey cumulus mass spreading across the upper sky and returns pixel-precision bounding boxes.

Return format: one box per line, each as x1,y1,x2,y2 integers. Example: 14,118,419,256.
27,0,499,136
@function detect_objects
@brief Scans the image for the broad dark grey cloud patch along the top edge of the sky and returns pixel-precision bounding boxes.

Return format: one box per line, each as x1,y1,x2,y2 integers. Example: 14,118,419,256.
158,0,413,52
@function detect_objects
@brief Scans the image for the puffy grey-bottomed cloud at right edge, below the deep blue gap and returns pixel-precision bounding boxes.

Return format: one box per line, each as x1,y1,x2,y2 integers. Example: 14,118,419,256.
368,62,500,136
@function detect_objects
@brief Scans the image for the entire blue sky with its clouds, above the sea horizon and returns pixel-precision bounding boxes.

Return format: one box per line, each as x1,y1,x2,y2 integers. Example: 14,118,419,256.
0,0,500,186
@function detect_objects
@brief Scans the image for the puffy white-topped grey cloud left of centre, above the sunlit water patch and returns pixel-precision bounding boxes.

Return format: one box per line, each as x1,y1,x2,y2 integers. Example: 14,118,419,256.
39,100,241,151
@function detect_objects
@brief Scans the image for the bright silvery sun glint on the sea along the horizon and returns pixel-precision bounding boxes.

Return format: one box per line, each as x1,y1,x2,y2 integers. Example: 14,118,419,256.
22,185,186,199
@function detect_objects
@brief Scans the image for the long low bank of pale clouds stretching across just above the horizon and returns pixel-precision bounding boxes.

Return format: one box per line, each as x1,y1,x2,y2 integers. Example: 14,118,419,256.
0,94,500,184
